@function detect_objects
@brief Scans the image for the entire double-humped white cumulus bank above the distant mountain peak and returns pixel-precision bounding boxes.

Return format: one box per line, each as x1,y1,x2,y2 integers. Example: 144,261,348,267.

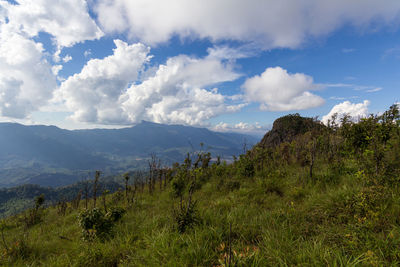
58,40,243,125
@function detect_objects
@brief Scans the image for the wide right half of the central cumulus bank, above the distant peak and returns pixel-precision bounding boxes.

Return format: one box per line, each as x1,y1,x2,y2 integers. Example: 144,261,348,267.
121,55,244,125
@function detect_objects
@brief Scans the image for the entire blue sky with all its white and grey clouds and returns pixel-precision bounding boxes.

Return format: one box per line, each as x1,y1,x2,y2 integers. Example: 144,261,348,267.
0,0,400,135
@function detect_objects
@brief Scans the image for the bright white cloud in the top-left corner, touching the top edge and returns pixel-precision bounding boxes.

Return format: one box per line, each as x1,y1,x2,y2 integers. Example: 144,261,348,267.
0,0,103,47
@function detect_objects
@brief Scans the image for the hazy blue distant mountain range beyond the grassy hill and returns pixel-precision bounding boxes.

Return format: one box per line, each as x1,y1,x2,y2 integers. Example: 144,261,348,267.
0,121,259,187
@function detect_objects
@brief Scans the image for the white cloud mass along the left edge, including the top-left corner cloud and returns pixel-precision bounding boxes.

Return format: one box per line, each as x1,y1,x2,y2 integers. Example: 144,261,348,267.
0,0,103,119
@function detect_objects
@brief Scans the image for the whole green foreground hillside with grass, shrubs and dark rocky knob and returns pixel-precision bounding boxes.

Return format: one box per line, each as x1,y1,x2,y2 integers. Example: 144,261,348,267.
0,105,400,266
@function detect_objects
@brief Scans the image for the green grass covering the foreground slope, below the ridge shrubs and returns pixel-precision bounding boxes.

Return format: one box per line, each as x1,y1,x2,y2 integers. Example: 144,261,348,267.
1,156,400,266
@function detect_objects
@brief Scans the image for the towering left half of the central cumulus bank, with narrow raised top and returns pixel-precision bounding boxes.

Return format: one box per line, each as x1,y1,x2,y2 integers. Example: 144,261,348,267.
57,40,150,123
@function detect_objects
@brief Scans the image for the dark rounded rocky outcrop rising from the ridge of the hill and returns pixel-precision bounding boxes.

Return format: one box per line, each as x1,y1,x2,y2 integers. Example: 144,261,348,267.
259,114,324,148
